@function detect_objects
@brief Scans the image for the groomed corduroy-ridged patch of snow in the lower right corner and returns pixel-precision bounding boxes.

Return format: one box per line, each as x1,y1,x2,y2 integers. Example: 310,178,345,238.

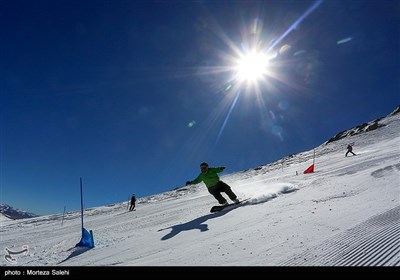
280,206,400,266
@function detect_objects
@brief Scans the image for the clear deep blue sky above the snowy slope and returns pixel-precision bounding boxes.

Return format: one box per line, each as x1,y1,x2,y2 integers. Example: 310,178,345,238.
0,0,400,214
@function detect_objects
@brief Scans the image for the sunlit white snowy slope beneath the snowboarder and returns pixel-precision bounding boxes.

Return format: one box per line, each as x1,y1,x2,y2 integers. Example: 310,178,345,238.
0,105,400,267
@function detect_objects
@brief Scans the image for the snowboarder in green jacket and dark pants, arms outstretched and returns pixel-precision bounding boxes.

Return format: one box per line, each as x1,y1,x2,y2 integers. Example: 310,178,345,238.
186,162,239,205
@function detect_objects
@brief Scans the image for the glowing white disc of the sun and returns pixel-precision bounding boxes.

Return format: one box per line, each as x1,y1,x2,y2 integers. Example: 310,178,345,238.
236,51,268,82
